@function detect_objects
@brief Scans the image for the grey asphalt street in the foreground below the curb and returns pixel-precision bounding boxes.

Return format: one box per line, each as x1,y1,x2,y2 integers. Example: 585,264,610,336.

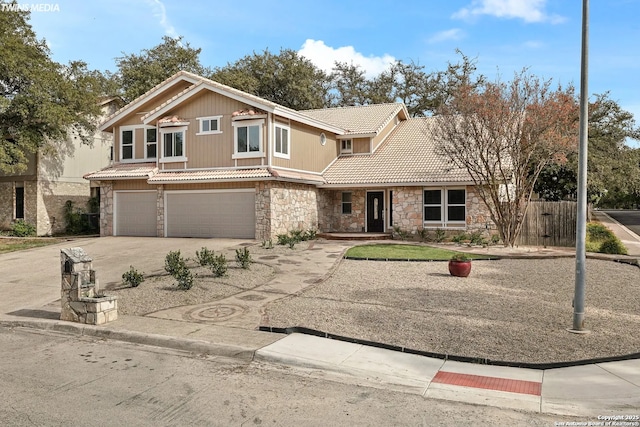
0,328,575,426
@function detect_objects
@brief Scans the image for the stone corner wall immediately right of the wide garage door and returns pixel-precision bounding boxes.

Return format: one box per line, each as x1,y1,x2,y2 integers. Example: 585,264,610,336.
256,181,318,240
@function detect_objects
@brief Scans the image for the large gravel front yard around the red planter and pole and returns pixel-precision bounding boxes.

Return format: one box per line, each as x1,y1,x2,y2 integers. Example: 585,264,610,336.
267,258,640,363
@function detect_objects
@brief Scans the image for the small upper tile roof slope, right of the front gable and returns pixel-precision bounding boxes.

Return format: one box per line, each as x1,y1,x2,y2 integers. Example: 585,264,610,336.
300,103,405,135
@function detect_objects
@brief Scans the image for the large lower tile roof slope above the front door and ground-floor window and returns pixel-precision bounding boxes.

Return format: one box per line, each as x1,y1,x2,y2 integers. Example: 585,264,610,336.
323,117,471,185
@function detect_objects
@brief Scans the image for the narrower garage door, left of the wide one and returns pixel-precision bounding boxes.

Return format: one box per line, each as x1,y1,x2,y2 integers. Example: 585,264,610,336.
113,191,157,237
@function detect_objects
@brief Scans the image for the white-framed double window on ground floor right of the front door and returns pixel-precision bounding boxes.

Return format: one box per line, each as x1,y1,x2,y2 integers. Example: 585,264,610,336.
423,188,467,227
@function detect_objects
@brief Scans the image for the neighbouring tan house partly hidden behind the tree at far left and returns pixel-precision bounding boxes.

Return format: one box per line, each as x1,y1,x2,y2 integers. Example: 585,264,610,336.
0,98,122,236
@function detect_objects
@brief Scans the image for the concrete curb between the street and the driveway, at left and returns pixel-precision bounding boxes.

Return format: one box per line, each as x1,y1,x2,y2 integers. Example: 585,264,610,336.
0,319,258,362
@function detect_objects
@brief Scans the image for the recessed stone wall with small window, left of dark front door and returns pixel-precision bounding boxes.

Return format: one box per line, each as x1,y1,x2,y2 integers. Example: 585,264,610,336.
319,189,367,233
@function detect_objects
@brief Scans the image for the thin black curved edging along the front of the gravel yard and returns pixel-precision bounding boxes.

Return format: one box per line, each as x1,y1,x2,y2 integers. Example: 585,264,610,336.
258,326,640,370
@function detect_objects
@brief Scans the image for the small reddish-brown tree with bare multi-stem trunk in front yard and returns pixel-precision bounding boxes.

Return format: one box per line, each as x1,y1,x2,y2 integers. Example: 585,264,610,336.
434,70,578,246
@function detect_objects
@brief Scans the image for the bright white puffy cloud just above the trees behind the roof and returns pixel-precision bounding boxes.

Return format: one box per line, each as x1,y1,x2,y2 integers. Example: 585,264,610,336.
298,39,396,78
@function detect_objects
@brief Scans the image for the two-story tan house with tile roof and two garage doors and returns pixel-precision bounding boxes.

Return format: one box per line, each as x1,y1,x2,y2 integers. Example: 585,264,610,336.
85,72,488,240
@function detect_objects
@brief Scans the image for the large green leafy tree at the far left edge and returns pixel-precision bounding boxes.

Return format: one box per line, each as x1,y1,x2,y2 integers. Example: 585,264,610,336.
0,5,100,173
